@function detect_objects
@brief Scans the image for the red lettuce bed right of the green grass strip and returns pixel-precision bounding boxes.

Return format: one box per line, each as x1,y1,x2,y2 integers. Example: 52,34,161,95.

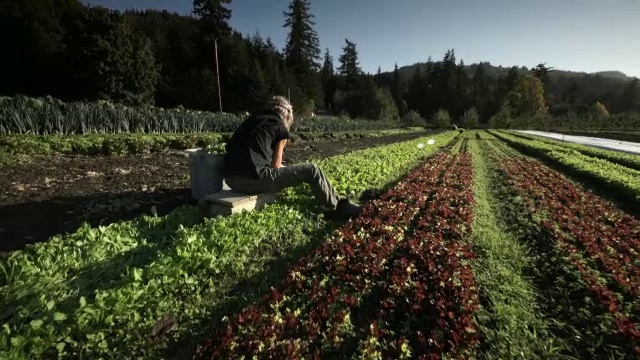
492,143,640,353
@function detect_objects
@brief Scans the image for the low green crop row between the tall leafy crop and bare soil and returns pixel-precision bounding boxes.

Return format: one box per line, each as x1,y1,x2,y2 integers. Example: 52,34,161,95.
0,128,424,155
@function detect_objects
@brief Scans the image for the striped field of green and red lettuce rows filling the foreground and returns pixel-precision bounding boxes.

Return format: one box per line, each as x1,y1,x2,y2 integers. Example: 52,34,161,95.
0,131,640,359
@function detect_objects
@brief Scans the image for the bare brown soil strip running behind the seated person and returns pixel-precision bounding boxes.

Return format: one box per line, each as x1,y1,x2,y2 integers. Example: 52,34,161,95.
0,132,436,254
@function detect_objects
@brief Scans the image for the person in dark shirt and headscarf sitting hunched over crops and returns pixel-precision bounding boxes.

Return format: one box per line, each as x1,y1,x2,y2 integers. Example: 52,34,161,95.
223,96,361,218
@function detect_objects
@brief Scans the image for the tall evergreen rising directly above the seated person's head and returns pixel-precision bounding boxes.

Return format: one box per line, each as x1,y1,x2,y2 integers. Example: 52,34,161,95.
284,0,320,107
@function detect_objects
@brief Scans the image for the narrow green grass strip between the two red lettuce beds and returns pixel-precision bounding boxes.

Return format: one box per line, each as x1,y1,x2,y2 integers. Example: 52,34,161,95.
470,136,556,359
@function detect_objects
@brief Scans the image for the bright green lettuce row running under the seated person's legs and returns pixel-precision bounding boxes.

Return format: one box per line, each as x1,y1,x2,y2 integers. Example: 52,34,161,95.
0,132,458,359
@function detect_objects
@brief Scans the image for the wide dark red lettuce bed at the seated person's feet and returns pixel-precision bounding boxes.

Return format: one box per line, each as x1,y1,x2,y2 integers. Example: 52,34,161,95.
198,148,477,359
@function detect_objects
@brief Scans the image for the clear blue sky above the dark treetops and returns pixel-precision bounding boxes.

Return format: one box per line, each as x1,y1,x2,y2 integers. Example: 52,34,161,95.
83,0,640,77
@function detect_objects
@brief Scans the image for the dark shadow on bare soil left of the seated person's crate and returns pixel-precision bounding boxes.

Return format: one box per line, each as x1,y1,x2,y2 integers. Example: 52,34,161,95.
0,189,196,255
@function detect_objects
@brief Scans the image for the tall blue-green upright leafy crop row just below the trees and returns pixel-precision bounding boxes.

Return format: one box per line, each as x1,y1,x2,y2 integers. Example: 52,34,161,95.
0,96,399,135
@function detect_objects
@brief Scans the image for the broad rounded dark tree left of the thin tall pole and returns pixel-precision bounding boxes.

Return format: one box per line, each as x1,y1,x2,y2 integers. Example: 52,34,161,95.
65,7,159,105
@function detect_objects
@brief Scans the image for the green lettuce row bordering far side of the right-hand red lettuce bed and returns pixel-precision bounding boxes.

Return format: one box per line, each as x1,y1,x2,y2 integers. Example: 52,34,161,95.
491,131,640,207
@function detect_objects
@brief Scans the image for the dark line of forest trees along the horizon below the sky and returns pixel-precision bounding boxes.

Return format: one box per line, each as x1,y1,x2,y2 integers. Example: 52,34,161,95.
0,0,640,125
